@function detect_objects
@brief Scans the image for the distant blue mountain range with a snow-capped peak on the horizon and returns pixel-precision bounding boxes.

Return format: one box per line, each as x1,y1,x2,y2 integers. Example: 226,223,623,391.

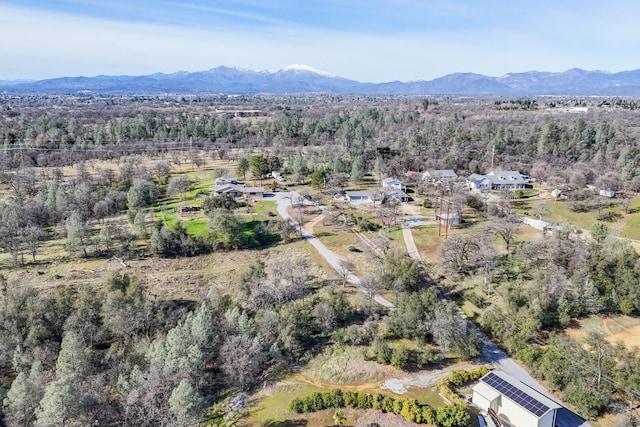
0,65,640,96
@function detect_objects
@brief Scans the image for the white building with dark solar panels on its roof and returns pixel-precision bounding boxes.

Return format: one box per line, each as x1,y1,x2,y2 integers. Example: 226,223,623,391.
471,371,562,427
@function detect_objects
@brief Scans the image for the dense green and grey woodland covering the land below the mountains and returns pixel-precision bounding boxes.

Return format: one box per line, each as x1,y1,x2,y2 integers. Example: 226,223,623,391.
0,95,640,426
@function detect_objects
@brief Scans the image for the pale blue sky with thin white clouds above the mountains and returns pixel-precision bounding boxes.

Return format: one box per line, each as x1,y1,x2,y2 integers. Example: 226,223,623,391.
0,0,640,83
